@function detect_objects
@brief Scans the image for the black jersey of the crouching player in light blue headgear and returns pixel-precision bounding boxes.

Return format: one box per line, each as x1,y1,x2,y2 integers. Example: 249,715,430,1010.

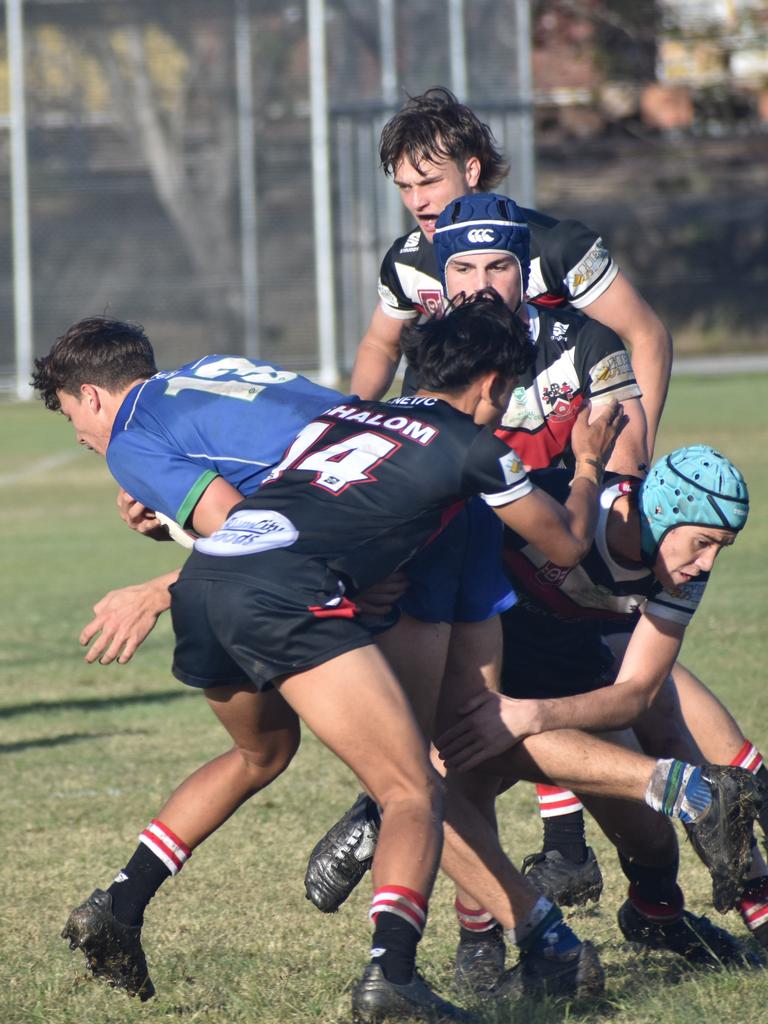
504,469,710,626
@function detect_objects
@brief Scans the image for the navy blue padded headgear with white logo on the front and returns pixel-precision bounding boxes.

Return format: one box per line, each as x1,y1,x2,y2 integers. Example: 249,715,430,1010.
432,193,530,293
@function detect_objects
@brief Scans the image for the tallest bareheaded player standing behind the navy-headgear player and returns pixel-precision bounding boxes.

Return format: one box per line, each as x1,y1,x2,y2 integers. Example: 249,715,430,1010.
351,88,672,452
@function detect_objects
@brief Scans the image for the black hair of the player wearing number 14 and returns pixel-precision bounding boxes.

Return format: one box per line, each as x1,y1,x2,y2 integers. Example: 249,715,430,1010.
402,289,536,392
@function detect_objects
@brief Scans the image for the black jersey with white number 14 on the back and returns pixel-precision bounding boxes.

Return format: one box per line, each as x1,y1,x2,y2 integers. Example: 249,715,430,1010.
186,396,532,593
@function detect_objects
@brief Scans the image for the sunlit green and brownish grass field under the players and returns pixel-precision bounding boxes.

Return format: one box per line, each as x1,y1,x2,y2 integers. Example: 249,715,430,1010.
0,377,768,1024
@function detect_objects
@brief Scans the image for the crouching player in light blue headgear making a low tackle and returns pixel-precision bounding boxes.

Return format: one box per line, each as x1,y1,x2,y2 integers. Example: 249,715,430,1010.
437,445,768,966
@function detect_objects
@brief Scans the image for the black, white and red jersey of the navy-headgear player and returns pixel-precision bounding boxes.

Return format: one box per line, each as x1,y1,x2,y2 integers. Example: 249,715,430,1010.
497,305,641,469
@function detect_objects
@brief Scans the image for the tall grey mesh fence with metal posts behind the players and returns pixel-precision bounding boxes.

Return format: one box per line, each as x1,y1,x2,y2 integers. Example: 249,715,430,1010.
0,0,534,388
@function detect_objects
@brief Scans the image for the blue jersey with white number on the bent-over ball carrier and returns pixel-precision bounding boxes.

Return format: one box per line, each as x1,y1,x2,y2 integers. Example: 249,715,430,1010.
106,355,343,525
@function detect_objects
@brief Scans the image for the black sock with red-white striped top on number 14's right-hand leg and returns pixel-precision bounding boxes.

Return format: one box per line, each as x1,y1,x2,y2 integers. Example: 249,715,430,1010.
369,886,427,985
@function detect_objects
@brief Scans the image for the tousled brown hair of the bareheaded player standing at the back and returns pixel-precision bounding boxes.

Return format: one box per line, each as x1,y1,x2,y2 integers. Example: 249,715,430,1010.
379,86,509,191
